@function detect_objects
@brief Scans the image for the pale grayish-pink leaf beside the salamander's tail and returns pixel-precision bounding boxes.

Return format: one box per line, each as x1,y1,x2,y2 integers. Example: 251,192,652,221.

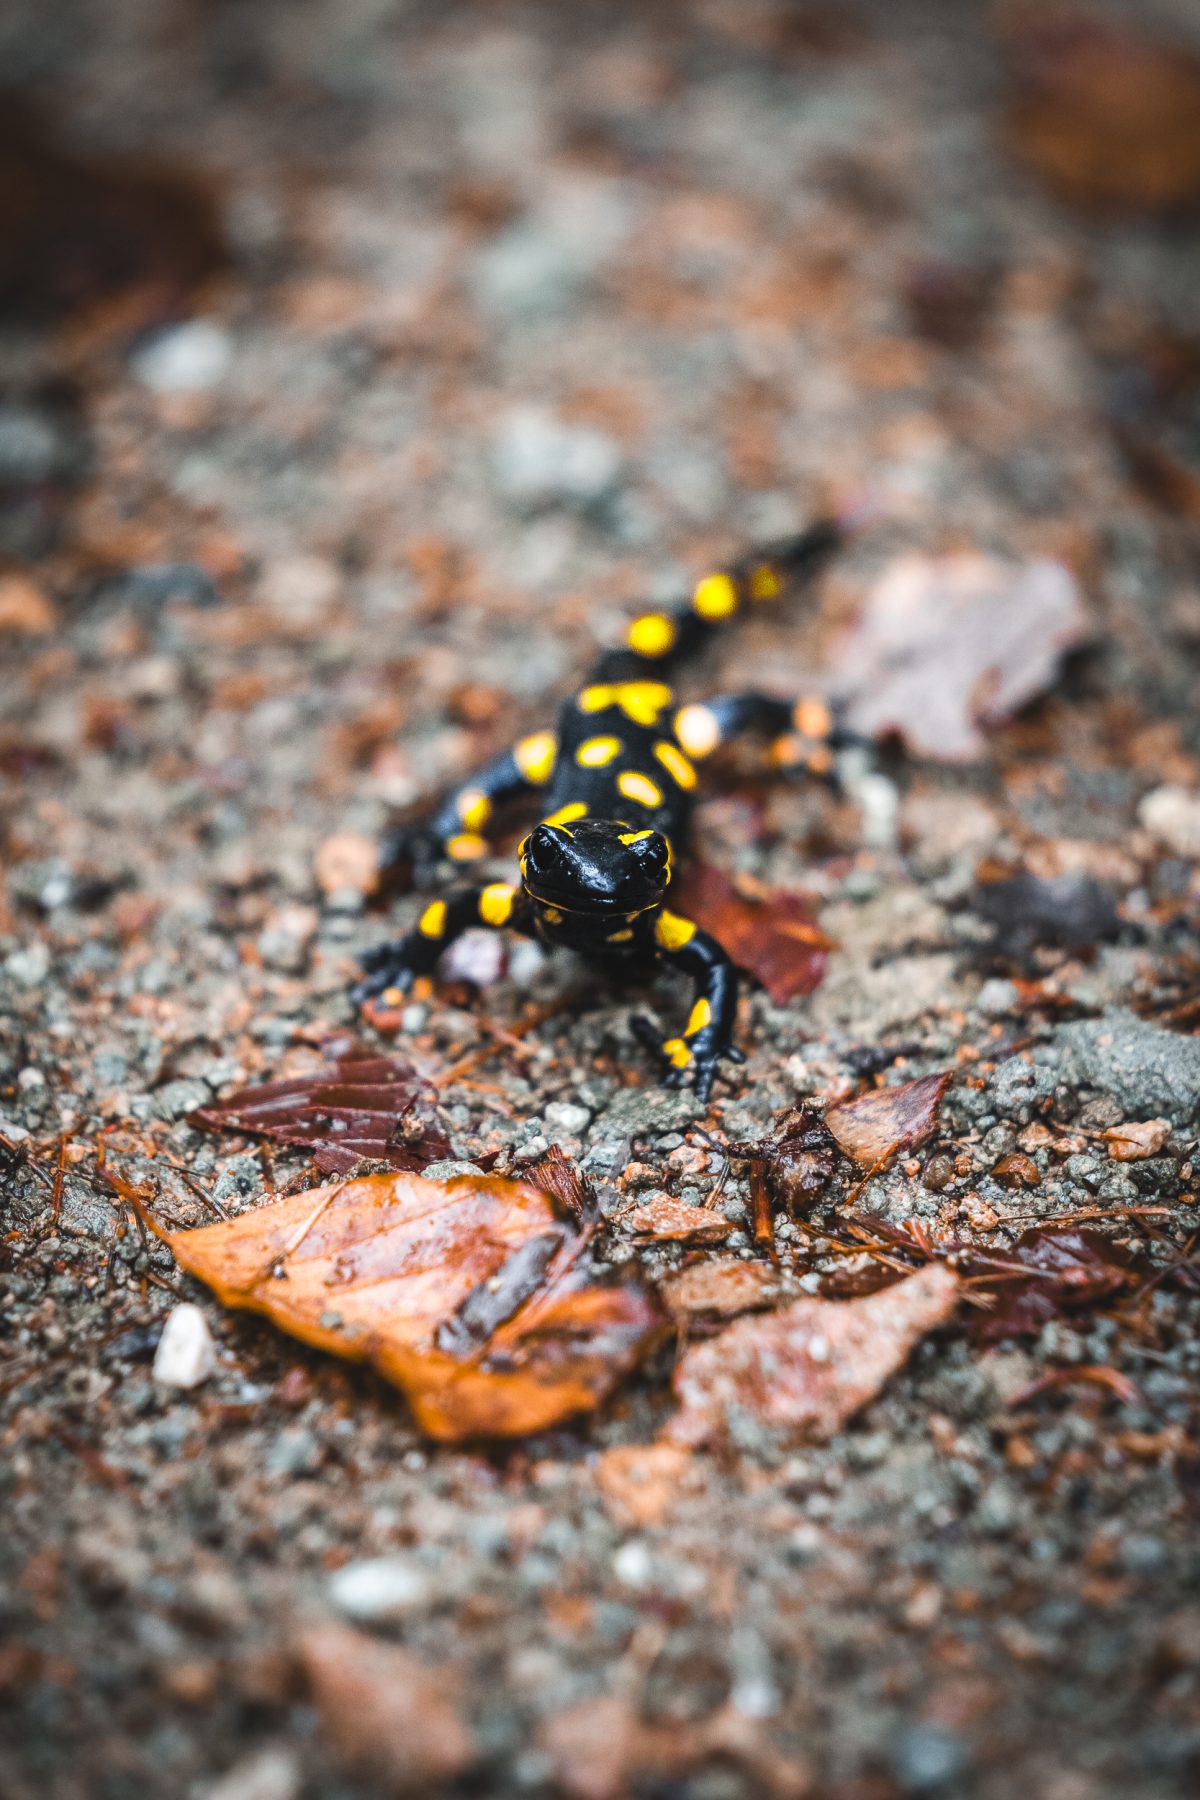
838,551,1088,761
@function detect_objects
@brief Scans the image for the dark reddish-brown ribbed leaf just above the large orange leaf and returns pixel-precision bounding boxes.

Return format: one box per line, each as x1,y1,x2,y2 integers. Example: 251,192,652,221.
189,1040,453,1175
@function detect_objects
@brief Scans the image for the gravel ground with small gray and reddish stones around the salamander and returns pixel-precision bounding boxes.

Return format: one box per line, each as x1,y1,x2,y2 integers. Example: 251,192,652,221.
0,0,1200,1800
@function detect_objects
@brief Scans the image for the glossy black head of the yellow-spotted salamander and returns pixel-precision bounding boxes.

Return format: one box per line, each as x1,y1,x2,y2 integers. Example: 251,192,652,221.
520,819,671,918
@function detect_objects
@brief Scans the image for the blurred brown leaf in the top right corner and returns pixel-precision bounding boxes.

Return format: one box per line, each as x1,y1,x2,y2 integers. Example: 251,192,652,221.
1009,9,1200,212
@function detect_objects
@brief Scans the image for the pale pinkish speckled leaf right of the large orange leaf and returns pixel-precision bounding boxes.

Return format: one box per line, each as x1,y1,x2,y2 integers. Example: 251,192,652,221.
666,1264,959,1445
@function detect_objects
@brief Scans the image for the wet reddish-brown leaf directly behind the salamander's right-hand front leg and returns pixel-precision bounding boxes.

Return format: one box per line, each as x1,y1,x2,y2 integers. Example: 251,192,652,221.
671,862,833,1006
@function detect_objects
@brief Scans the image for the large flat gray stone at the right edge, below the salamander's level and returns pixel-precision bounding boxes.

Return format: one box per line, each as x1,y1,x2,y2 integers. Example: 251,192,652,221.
1058,1012,1200,1125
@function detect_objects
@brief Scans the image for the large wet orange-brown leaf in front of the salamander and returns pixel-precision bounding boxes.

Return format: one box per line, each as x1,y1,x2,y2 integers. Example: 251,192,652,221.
166,1174,660,1440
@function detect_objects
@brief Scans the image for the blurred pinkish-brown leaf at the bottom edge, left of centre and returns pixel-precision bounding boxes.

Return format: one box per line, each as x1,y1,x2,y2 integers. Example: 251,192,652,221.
297,1622,475,1795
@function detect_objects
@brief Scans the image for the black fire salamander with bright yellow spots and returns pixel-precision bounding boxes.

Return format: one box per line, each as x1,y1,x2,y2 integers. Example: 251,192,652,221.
351,520,859,1100
